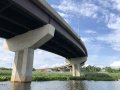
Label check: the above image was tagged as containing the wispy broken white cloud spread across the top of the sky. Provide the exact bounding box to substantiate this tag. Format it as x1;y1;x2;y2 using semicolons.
52;0;120;23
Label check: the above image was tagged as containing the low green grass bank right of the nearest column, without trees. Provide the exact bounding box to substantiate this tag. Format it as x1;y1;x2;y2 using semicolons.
33;72;120;81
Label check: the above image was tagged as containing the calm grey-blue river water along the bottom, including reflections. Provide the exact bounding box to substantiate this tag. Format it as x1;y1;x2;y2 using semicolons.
0;81;120;90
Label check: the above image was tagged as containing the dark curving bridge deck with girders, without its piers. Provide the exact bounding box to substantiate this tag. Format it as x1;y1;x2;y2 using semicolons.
0;0;87;58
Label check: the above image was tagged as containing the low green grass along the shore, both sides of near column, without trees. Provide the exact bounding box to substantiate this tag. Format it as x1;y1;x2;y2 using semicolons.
0;70;120;81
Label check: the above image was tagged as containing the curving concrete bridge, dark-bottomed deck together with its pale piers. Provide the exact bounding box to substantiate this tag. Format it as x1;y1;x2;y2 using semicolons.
0;0;87;82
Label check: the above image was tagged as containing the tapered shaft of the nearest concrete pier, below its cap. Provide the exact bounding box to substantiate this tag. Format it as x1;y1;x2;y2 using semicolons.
11;48;34;82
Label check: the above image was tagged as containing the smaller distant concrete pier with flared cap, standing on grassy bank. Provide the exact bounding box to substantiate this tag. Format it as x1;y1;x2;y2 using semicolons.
66;57;87;76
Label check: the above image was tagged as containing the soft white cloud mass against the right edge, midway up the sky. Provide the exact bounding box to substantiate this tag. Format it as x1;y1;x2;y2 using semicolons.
97;14;120;51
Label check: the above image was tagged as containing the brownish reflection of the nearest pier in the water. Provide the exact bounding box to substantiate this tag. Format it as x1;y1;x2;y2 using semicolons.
10;83;31;90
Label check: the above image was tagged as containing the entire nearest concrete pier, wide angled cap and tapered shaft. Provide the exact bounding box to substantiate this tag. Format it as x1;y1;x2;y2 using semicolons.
4;24;55;82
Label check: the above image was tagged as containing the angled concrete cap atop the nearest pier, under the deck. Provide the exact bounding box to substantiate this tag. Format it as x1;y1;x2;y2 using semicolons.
3;24;55;52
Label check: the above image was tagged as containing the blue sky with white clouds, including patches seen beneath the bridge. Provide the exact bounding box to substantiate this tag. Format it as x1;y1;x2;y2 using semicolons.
0;0;120;68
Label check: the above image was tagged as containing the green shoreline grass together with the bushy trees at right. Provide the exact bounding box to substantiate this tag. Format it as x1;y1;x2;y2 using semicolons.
0;66;120;81
